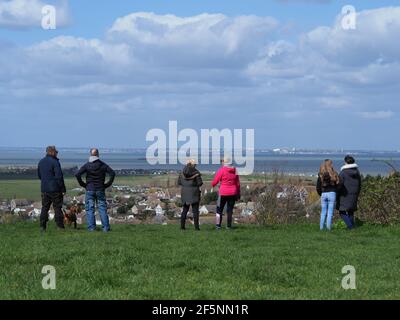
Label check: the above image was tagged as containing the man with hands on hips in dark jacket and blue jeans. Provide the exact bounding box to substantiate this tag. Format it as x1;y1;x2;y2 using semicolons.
75;149;115;232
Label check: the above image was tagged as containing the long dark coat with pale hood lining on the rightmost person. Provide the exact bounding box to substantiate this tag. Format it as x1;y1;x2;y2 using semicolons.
338;164;361;212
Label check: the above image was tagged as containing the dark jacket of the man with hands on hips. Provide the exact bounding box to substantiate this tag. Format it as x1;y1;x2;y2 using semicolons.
75;160;115;191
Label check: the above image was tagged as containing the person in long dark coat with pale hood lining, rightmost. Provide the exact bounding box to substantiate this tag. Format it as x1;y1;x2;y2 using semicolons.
338;156;361;230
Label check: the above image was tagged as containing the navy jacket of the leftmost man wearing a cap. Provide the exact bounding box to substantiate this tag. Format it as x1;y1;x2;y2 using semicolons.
38;156;66;193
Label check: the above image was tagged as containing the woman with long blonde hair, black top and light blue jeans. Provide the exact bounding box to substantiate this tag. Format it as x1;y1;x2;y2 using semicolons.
317;159;340;231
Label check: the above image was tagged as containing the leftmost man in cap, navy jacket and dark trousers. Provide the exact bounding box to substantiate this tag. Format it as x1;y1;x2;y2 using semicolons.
38;146;66;231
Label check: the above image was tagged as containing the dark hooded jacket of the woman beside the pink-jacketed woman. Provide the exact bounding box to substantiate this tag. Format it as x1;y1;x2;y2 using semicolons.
178;167;203;205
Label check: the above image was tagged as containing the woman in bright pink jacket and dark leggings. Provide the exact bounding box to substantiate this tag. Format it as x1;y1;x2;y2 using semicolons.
212;158;240;230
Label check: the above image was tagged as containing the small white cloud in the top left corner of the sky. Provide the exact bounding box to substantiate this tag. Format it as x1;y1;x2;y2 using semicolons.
0;0;69;28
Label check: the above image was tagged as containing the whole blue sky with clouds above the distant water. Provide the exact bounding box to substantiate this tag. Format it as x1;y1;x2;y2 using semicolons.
0;0;400;150
